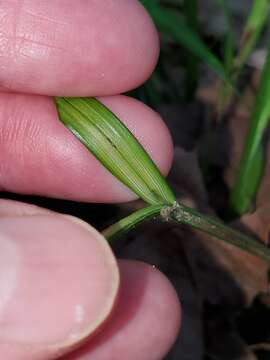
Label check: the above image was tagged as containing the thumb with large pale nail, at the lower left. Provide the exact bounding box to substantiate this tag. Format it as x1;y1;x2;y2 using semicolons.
0;213;119;360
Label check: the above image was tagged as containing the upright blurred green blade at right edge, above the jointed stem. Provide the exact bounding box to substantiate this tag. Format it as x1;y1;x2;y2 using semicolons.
230;48;270;214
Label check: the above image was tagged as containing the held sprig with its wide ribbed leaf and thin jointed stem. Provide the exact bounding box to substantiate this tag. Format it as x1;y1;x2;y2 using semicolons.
55;97;270;263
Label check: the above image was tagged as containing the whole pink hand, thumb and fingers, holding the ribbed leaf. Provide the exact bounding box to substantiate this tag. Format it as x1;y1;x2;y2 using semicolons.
0;0;180;360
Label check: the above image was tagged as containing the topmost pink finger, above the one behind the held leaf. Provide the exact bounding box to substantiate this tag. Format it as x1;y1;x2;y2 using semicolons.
0;0;159;96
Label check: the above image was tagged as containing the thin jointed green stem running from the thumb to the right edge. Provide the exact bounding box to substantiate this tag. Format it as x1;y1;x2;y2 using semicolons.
103;202;270;263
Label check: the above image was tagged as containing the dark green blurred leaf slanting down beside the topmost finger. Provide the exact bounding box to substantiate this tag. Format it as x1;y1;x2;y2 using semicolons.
141;0;230;82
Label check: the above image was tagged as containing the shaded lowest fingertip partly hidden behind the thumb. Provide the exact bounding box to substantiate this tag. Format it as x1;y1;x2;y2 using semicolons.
65;260;181;360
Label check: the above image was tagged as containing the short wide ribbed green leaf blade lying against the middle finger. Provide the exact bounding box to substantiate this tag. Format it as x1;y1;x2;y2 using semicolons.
55;97;175;205
